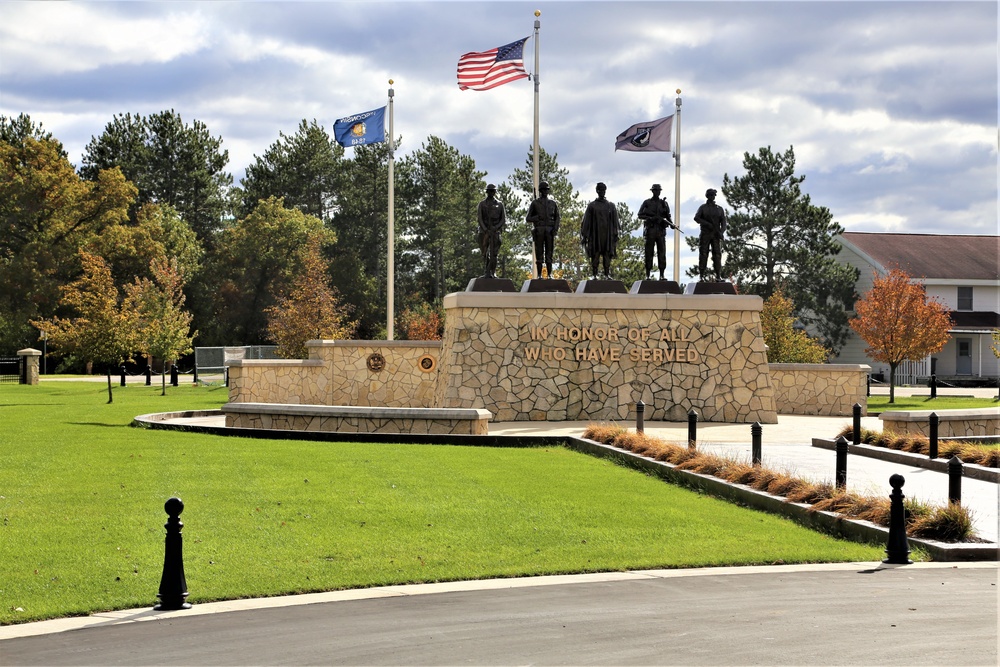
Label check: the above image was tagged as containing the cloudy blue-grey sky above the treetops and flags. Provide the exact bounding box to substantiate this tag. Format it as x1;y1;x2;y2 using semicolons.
0;0;998;247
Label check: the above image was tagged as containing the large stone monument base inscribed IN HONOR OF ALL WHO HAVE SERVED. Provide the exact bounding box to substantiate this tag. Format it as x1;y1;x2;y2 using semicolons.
434;292;777;424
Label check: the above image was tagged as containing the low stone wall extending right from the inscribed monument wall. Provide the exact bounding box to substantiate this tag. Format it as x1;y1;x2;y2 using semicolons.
768;364;871;417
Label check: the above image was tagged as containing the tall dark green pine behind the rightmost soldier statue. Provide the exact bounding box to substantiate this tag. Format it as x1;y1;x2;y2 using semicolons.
687;146;858;353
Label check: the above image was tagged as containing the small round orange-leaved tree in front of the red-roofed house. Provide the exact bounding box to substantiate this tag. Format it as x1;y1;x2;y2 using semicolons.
850;269;952;403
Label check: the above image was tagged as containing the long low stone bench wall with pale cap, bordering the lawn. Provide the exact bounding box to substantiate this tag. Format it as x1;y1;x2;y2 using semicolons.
222;403;493;435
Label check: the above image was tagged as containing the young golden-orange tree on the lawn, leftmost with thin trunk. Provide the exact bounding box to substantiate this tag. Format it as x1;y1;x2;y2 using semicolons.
31;251;140;403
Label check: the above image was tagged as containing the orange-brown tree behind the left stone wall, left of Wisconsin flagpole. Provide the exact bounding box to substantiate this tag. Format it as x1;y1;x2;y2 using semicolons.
267;237;357;359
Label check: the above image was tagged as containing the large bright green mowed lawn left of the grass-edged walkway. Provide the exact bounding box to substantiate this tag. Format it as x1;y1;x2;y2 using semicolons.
0;381;883;624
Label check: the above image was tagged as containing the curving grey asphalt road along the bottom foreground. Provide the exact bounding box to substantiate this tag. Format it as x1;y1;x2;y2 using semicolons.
0;563;998;666
